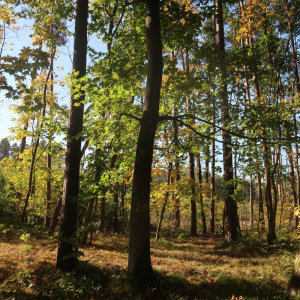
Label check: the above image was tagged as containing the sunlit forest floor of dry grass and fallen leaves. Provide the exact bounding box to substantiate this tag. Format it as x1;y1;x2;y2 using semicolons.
0;230;299;300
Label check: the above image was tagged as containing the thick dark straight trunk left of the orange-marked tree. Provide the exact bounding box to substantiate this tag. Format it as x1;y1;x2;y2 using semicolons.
56;0;88;270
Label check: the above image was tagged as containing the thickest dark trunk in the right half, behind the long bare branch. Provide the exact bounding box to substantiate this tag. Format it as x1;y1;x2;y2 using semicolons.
216;0;238;243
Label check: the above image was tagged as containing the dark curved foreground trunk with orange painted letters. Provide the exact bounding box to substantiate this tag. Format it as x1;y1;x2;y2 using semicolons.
128;0;163;281
